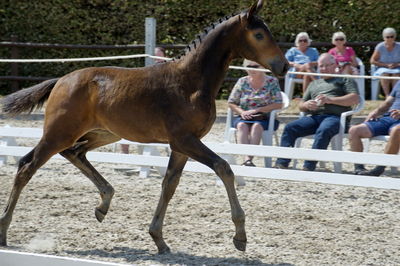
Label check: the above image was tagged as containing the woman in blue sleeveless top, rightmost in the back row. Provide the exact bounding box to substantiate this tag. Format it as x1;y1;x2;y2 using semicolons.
371;28;400;97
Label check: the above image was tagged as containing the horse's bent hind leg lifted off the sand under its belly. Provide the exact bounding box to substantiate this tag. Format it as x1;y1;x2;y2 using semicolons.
60;130;120;222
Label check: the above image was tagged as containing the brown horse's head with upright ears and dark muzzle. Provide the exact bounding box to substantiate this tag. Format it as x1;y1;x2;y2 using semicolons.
236;0;289;76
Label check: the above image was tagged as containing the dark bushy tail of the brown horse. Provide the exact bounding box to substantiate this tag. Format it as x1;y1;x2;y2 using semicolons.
1;78;58;115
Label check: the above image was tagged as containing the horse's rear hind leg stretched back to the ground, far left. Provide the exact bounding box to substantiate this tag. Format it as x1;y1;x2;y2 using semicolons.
0;139;69;246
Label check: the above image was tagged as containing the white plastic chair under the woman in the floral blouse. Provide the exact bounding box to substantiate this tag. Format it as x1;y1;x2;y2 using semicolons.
224;92;289;167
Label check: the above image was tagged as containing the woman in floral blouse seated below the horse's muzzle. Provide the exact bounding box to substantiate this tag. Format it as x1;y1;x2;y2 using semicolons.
228;59;282;166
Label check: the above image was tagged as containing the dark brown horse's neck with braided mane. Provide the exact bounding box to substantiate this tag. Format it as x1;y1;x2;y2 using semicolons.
183;19;236;99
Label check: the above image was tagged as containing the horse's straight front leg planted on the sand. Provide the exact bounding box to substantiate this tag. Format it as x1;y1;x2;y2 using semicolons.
149;151;188;254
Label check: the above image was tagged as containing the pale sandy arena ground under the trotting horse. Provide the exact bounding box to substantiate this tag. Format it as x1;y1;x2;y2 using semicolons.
0;116;400;265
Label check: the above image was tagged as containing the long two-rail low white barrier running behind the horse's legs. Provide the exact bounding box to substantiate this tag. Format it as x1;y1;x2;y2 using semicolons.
0;128;400;189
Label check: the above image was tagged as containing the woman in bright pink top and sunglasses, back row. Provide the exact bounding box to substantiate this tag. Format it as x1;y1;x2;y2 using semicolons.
328;31;359;75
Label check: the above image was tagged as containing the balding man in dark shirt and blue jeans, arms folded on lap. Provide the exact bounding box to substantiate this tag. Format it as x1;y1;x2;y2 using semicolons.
275;53;359;171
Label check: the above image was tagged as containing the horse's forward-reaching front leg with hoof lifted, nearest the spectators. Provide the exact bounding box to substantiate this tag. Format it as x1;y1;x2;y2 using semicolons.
170;135;247;251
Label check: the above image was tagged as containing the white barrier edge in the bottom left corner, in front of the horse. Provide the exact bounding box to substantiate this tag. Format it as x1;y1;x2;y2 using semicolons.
0;250;132;266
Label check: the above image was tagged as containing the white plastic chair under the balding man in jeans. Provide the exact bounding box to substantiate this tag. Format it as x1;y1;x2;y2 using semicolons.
293;95;365;173
